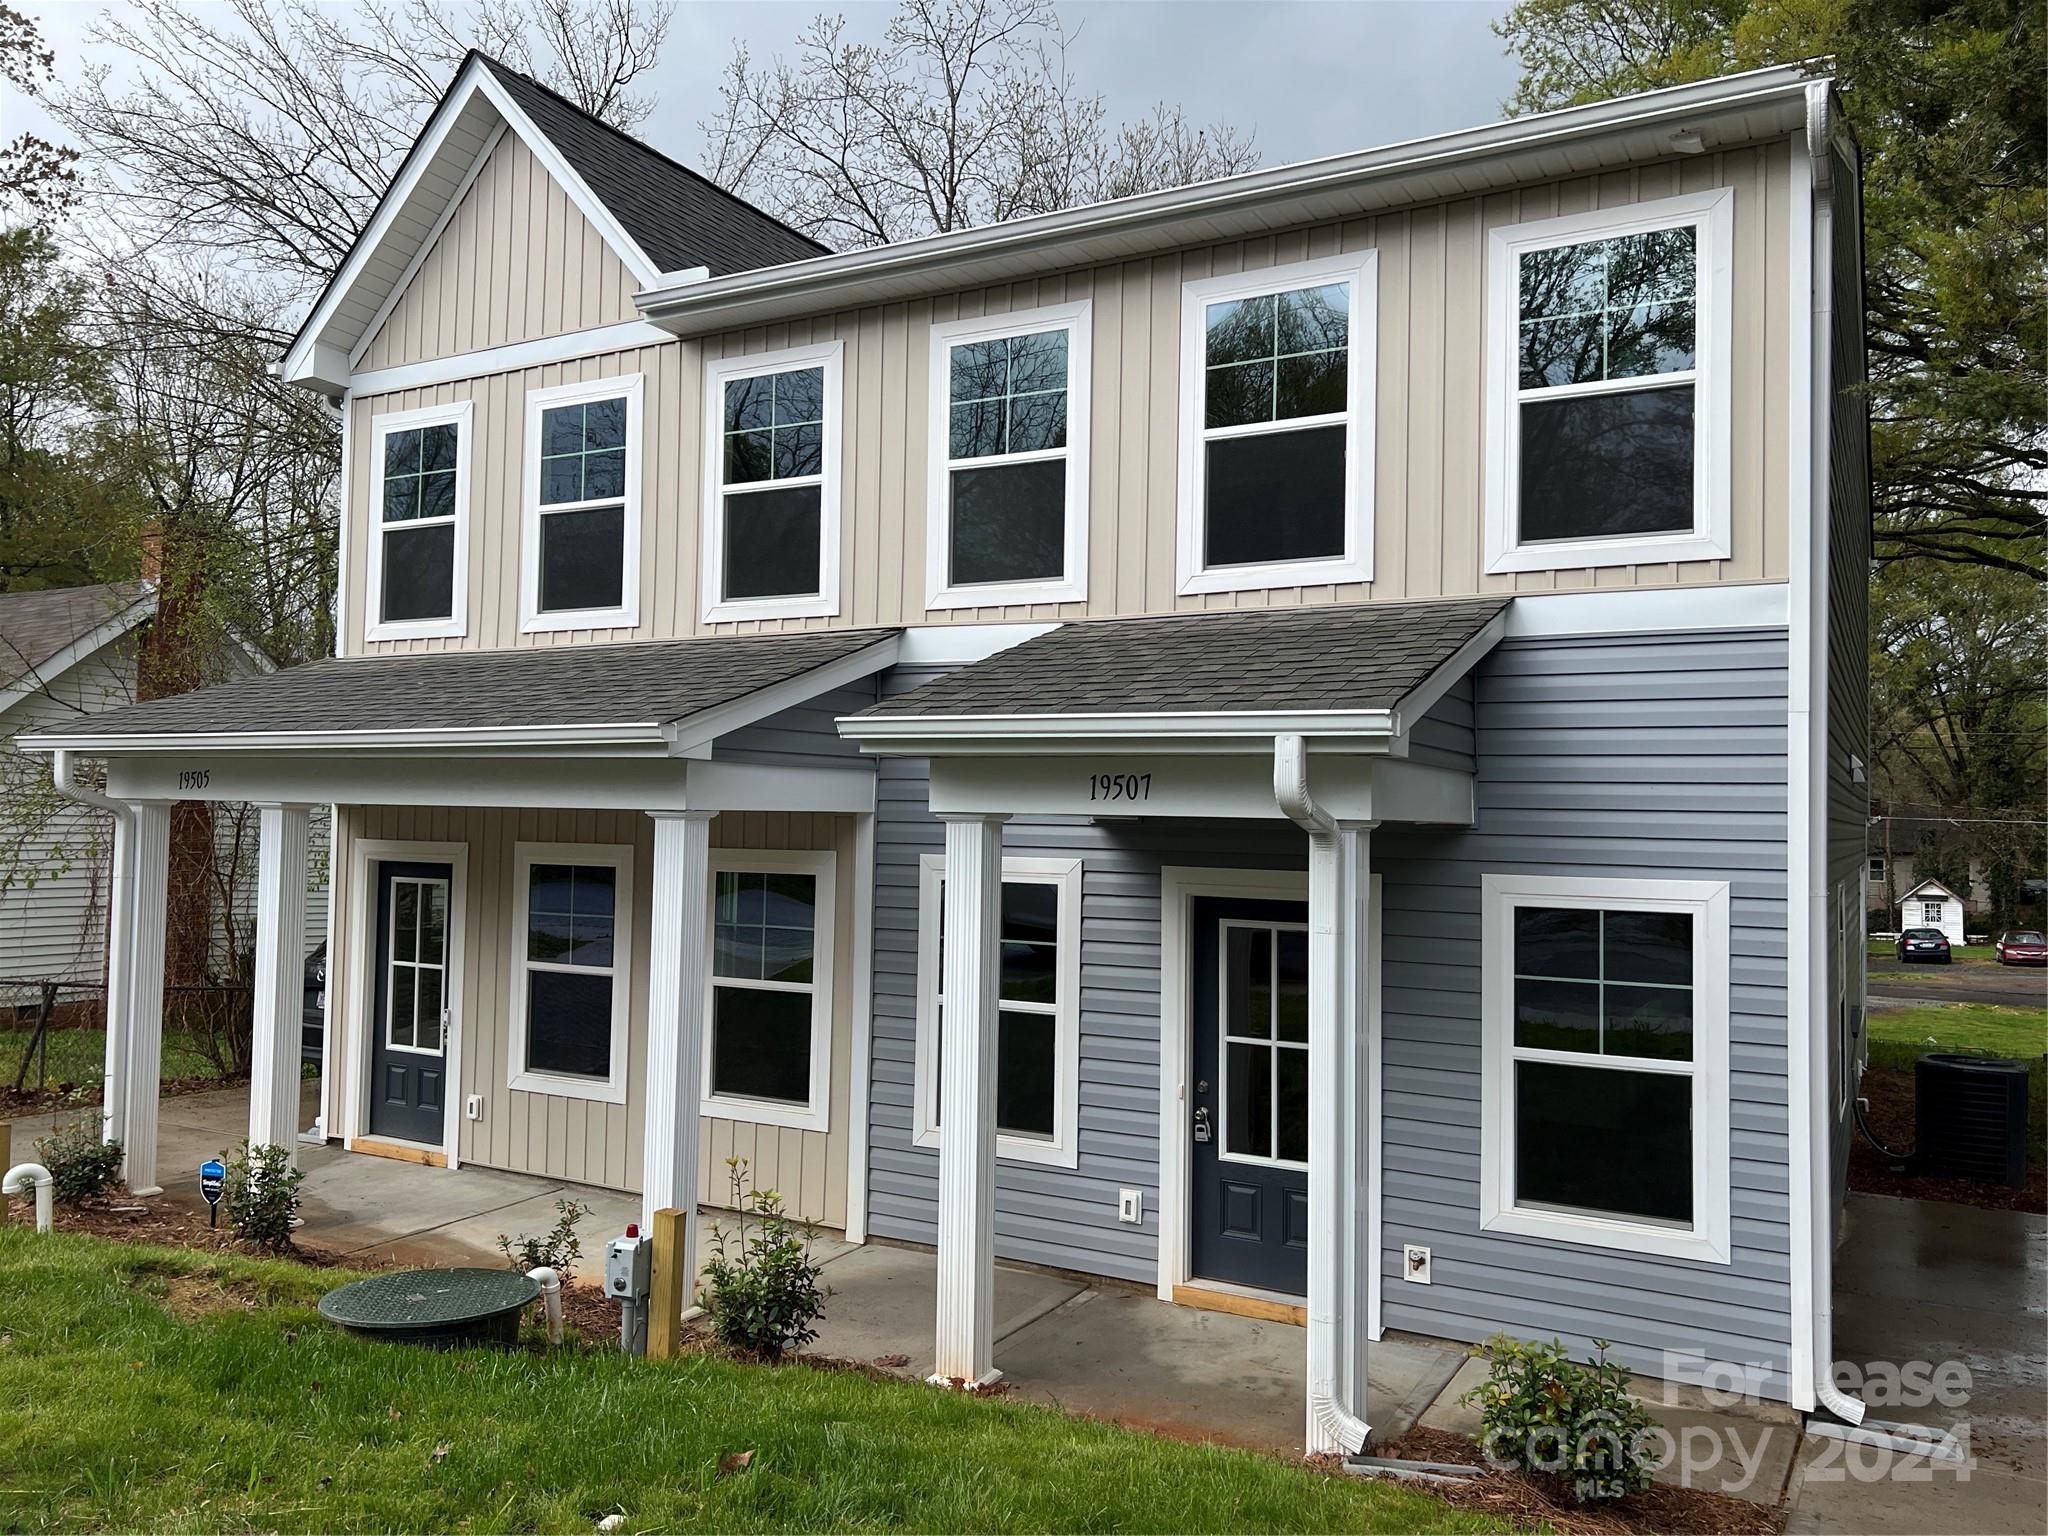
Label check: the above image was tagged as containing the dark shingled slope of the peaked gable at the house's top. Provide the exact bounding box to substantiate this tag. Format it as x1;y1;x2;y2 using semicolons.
477;53;829;276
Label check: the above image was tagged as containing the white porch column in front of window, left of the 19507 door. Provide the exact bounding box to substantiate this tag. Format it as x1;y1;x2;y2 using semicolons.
932;815;1008;1386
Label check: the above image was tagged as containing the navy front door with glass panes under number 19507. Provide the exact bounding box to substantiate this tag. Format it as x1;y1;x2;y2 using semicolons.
1190;899;1309;1296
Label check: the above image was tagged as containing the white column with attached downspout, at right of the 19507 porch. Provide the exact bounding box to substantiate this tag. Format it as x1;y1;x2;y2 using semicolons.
1274;735;1372;1454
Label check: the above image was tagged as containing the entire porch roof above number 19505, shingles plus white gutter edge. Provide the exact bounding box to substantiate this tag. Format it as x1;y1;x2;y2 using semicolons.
20;629;899;756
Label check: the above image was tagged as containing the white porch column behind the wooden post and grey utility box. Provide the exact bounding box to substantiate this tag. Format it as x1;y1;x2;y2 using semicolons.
641;811;717;1245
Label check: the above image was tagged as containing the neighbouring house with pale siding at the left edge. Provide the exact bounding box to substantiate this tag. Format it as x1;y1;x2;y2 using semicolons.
0;582;326;1008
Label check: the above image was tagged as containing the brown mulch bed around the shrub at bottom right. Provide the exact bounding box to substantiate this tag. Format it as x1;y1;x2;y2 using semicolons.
1372;1427;1784;1536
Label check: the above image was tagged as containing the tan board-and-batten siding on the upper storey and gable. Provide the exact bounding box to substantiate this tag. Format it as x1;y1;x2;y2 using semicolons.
344;139;1792;651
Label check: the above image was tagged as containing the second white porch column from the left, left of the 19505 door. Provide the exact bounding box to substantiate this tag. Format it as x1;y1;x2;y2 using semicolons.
250;801;307;1161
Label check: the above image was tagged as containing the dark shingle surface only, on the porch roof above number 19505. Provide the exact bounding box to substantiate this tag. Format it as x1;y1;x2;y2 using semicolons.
51;629;895;737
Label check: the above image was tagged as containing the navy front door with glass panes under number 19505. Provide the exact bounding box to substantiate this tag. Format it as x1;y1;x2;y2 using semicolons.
371;864;451;1147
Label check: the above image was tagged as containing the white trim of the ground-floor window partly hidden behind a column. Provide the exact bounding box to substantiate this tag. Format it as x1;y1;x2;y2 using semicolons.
911;854;1081;1167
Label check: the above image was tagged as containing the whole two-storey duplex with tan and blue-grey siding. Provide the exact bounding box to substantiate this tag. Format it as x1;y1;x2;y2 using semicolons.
19;57;1868;1450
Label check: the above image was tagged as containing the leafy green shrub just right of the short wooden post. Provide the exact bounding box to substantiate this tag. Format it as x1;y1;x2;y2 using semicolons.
698;1157;831;1360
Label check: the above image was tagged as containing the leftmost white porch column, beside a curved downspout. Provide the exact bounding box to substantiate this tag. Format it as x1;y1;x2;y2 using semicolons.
100;801;170;1196
